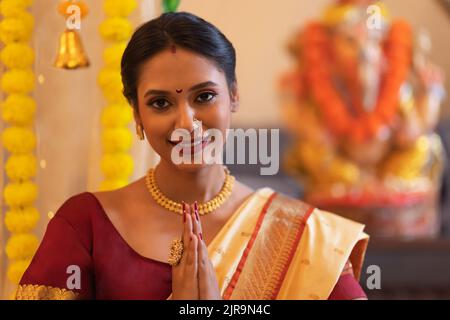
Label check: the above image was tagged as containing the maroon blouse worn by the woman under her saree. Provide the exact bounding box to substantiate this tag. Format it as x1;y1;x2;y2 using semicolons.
20;192;365;300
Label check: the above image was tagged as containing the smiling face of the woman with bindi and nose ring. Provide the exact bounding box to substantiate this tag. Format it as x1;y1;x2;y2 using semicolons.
134;47;238;169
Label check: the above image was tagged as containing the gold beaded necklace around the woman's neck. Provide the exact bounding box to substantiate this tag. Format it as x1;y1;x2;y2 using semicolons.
145;167;234;215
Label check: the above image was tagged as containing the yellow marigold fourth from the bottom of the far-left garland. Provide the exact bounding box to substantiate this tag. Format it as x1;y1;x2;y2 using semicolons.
3;181;38;209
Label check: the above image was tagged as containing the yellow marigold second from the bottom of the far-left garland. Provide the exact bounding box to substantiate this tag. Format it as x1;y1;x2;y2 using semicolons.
5;233;39;260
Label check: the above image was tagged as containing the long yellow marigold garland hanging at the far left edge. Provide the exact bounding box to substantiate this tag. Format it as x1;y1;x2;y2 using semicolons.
0;0;39;290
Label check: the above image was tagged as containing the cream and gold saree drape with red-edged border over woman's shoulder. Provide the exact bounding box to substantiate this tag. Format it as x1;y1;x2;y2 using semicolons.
208;188;368;300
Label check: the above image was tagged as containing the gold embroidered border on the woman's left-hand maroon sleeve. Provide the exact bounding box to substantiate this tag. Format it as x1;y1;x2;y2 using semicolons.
15;284;78;300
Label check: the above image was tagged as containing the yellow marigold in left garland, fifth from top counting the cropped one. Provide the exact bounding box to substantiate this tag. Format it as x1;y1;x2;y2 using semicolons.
0;94;36;126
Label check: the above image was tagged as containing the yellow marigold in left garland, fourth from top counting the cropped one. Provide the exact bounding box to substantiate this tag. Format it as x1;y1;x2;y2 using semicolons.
1;69;35;94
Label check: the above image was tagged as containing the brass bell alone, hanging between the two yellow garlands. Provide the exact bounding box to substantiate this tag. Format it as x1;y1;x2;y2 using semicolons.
54;29;89;69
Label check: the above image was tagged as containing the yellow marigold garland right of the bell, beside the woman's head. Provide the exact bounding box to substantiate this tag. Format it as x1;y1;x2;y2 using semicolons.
97;0;137;190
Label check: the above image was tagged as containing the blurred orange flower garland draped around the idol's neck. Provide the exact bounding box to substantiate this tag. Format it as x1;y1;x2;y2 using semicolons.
303;21;413;143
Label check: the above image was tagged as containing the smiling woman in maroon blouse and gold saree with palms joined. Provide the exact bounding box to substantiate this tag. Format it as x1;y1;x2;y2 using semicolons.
16;12;368;300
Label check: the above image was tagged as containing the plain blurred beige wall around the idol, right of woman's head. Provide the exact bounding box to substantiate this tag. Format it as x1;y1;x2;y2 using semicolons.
179;0;450;127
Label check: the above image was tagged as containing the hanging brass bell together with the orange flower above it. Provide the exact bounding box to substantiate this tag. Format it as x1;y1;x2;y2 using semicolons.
54;0;89;69
